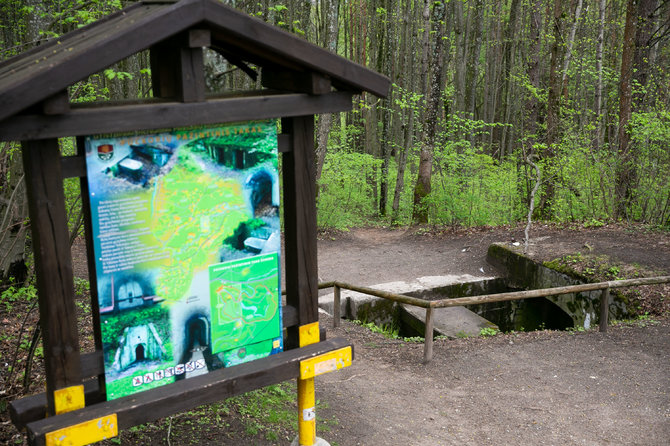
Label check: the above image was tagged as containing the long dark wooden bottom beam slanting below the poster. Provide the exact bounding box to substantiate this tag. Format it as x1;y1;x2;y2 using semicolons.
26;338;351;445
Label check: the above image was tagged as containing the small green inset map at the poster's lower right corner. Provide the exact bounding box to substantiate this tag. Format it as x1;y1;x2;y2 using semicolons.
209;253;281;353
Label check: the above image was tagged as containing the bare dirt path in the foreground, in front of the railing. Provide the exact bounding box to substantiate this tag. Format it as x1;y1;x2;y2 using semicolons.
316;317;670;446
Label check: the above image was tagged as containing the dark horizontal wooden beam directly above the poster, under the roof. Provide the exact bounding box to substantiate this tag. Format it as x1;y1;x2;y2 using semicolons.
0;92;352;141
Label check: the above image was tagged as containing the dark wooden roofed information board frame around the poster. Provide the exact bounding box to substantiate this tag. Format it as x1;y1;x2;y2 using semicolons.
0;0;390;444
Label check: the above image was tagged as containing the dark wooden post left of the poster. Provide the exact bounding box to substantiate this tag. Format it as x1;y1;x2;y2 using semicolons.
23;139;81;415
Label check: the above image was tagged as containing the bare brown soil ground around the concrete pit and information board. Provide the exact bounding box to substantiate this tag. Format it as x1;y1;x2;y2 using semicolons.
0;226;670;446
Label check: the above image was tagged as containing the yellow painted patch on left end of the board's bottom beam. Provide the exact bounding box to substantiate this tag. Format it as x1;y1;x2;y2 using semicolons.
44;413;119;446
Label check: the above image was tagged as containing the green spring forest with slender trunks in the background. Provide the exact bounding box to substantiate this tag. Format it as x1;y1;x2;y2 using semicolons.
0;0;670;275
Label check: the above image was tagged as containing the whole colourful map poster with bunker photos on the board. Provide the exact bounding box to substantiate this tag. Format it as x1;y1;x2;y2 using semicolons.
85;121;283;400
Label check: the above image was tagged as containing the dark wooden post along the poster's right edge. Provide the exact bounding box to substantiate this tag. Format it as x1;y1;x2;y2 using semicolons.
282;115;319;349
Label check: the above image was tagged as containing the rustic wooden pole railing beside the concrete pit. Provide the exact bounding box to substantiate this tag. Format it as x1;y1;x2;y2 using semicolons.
319;276;670;363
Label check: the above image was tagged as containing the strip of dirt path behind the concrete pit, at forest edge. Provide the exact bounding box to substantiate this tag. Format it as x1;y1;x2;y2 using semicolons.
319;225;670;285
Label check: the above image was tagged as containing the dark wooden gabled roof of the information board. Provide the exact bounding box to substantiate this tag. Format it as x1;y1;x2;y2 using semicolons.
0;0;390;121
